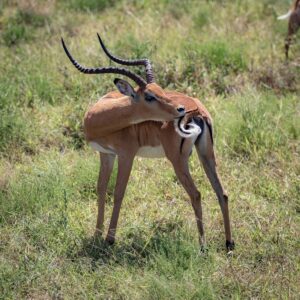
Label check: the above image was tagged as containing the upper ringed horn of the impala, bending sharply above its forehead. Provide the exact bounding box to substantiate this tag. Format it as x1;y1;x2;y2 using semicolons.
97;33;154;83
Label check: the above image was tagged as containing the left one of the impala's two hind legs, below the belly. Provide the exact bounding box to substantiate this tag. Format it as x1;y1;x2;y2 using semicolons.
172;155;206;250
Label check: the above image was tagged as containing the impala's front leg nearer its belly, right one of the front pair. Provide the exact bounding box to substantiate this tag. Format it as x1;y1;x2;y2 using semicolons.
106;155;134;244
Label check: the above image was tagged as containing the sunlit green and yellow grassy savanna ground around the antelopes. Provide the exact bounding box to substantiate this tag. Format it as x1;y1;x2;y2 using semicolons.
0;0;300;299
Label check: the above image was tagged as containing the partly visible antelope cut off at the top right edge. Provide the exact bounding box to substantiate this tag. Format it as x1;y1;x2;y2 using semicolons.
278;0;300;59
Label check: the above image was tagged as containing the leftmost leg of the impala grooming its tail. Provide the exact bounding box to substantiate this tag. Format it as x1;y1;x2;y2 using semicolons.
95;153;115;236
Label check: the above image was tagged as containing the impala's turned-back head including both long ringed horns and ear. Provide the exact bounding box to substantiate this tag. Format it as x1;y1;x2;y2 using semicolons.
62;34;186;121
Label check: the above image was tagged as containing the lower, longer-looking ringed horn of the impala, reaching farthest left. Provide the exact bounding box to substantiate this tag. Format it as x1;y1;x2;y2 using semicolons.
61;38;147;88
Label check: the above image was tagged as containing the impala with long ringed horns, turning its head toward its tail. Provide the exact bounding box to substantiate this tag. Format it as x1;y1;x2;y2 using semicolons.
62;34;234;251
